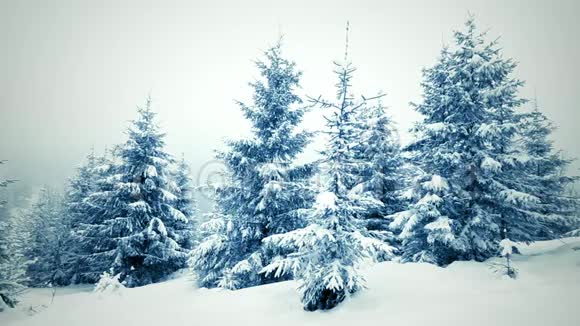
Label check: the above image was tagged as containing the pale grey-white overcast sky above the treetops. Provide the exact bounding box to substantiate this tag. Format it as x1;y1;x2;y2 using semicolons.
0;0;580;208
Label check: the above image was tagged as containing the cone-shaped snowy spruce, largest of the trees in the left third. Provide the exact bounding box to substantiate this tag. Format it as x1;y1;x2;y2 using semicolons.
81;98;193;287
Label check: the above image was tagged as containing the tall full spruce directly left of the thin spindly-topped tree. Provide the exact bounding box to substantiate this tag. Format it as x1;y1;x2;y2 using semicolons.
190;42;312;289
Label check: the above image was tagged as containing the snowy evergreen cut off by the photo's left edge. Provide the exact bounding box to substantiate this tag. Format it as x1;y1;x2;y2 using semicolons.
0;161;27;312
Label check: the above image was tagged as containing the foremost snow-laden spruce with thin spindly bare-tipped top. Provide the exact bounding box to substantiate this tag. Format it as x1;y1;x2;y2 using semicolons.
262;25;393;311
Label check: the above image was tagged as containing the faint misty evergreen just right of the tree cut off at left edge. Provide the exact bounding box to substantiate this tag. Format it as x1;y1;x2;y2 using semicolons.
26;188;74;287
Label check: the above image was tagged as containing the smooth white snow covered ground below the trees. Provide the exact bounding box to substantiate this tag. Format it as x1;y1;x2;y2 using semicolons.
0;238;580;326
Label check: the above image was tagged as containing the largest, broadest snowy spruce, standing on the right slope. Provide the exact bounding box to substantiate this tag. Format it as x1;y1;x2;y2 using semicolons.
393;17;538;265
